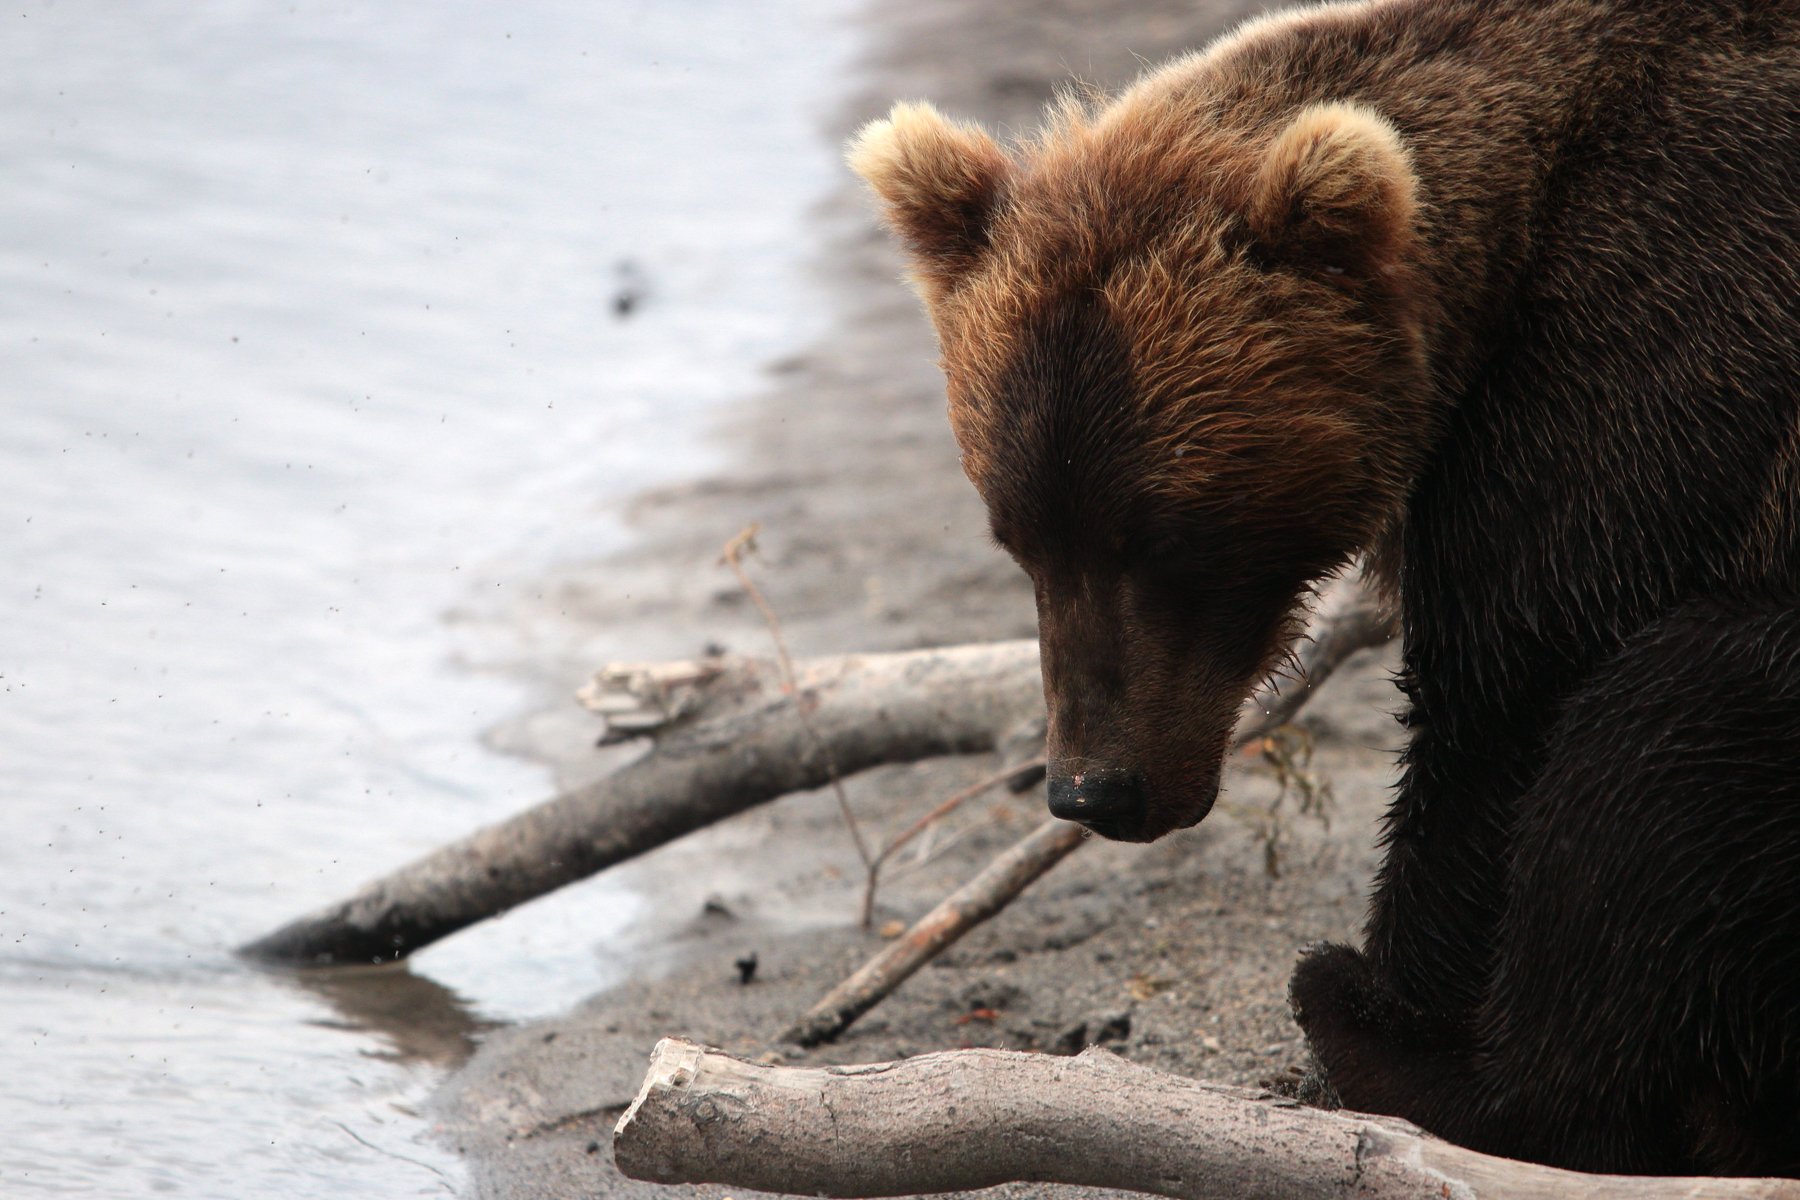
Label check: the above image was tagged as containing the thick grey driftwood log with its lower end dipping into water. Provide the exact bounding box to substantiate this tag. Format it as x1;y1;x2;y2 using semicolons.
239;640;1044;966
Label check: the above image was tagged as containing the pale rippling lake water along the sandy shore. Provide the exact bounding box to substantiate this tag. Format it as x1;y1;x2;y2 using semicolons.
0;0;851;1200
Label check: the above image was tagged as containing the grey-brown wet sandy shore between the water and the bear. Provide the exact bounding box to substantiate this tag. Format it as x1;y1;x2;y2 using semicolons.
437;0;1397;1200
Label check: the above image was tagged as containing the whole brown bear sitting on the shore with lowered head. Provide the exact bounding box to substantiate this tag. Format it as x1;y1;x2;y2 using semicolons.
851;0;1800;1173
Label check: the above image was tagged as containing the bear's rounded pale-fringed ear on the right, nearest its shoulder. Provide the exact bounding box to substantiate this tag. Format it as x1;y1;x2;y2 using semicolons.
1246;104;1418;282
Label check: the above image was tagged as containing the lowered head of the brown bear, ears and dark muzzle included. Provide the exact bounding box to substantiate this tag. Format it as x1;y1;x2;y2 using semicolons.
850;94;1431;840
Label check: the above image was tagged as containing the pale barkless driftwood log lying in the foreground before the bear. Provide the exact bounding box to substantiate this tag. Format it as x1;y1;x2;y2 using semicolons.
612;1038;1800;1200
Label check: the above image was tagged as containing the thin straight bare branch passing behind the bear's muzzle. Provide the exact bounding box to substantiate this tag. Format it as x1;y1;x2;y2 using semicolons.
781;578;1393;1045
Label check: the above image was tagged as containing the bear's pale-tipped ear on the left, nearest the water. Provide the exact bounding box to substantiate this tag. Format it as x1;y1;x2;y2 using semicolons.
850;104;1012;298
